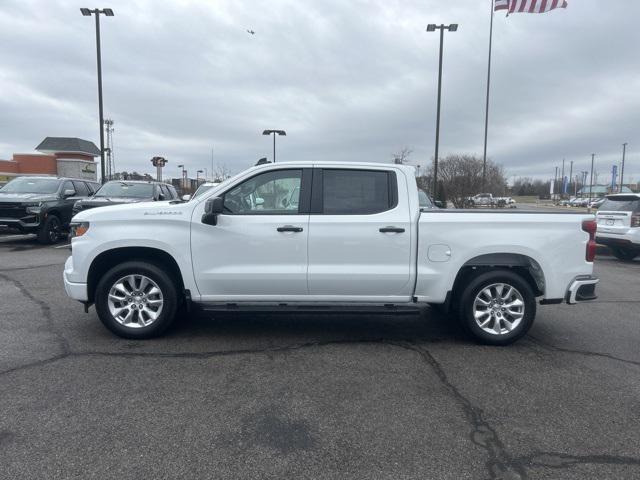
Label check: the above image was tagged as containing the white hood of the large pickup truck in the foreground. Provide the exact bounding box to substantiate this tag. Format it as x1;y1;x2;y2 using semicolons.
73;199;189;222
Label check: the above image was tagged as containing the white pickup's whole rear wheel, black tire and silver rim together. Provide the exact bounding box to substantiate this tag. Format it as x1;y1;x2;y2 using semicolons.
458;270;536;345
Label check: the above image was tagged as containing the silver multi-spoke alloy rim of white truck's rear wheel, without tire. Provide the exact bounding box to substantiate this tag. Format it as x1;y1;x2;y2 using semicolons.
473;283;524;335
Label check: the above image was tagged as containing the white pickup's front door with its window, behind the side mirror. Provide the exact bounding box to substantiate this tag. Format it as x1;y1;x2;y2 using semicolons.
191;169;311;301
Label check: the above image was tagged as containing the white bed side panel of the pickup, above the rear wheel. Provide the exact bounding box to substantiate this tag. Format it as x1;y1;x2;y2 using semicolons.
416;211;593;303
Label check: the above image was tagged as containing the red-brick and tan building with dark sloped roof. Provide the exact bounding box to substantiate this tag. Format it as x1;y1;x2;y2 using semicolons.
0;137;100;186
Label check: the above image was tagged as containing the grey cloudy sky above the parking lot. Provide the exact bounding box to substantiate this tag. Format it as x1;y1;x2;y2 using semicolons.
0;0;640;181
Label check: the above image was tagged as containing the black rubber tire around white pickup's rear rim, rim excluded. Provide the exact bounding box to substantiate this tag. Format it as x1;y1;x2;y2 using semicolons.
458;270;536;345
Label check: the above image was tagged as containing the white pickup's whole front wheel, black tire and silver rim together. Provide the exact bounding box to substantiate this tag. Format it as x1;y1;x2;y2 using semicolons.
95;261;178;339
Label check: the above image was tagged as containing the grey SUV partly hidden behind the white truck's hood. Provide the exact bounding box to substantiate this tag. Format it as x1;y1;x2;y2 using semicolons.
73;180;178;215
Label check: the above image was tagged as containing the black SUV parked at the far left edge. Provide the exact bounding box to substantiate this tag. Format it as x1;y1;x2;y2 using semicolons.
0;177;100;244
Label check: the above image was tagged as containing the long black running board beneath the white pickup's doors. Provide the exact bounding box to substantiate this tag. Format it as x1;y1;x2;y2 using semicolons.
198;302;424;314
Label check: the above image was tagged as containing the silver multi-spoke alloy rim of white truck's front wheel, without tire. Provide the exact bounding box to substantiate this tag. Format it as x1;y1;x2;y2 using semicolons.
107;274;164;328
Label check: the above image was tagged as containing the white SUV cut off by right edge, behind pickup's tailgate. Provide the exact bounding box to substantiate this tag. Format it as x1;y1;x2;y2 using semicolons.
596;193;640;261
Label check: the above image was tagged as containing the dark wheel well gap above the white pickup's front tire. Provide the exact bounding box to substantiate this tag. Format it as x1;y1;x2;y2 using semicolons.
87;247;184;303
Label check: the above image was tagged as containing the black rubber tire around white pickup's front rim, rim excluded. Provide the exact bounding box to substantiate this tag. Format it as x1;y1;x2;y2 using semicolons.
95;261;179;339
